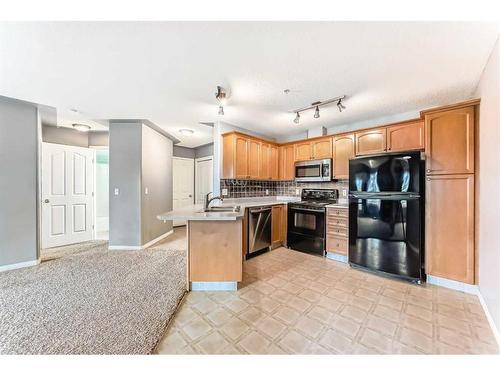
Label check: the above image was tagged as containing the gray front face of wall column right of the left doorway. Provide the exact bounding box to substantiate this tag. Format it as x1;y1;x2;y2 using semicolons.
109;123;142;246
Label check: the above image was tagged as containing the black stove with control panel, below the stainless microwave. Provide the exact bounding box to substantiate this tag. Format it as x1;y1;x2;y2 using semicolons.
287;189;339;256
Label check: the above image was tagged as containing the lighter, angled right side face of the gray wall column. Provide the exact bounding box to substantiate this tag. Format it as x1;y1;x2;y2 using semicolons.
141;125;173;244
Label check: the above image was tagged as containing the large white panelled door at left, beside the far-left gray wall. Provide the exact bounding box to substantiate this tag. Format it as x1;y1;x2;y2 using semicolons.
41;143;94;248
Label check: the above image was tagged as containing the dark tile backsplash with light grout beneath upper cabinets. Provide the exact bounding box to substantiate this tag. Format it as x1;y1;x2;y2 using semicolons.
220;179;349;198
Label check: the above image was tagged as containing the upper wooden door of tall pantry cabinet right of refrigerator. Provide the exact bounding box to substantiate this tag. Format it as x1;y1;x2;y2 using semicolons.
425;106;474;174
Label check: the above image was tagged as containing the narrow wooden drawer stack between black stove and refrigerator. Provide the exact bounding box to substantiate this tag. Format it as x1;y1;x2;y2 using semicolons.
326;208;349;256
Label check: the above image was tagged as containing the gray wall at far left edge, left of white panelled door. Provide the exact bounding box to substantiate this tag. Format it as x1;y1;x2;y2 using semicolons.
0;96;39;266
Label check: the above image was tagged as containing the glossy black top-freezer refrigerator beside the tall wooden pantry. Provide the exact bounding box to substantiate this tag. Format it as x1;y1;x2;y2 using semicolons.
349;152;425;283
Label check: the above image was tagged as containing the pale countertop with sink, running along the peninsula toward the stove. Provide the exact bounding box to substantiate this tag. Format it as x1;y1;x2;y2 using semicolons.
157;196;300;221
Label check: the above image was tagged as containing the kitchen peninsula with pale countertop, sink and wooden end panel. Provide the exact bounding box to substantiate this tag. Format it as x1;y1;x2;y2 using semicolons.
158;197;296;290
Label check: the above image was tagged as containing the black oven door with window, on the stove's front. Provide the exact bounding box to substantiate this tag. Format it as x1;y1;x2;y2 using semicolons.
287;206;325;255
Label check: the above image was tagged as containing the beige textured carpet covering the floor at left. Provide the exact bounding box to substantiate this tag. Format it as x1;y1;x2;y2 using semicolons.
0;242;186;354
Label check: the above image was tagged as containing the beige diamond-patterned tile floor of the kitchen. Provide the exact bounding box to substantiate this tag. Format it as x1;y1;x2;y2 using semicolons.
157;248;500;354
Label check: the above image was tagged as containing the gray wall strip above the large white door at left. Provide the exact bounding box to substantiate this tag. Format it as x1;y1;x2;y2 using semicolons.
42;125;109;147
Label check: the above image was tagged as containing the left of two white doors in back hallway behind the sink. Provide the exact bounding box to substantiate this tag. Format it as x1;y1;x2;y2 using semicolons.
172;157;194;226
